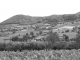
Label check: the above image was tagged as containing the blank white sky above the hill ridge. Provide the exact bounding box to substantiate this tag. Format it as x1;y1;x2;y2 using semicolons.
0;0;80;22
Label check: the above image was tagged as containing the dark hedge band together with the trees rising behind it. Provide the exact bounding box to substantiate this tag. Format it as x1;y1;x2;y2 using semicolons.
0;31;80;51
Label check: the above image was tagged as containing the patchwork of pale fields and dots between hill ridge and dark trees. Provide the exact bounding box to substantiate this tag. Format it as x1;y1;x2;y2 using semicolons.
0;21;80;41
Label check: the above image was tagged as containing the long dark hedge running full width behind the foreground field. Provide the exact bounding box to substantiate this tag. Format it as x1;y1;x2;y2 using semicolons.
0;38;80;51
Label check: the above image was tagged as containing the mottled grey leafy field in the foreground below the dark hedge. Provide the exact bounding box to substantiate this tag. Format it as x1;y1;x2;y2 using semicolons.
0;50;80;60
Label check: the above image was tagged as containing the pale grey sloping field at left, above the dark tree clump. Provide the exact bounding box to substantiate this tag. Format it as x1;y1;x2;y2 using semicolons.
0;30;39;42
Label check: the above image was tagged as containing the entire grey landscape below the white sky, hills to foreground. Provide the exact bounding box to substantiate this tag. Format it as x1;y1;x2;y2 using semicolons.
0;12;80;60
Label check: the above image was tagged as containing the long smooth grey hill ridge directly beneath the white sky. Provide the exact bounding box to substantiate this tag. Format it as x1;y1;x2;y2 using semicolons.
0;12;80;25
